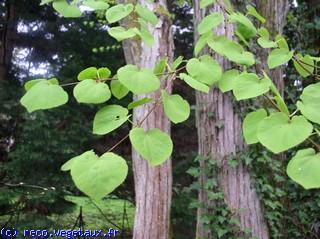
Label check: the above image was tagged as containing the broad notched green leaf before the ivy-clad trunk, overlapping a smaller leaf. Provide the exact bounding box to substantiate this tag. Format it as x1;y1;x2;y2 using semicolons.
233;72;271;100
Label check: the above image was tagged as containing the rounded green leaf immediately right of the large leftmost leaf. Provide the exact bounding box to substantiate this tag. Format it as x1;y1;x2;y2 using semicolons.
73;79;111;104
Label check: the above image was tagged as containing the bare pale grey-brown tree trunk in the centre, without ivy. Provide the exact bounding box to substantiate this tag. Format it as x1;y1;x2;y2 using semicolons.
120;0;174;239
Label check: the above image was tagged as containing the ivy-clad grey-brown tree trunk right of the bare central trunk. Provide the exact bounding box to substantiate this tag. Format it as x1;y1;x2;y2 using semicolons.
194;1;269;239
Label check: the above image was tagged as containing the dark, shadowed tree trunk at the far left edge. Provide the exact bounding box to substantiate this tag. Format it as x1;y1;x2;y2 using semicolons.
0;0;18;81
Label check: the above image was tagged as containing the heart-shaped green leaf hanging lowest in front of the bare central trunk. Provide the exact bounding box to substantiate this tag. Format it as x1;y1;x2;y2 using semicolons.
129;128;173;166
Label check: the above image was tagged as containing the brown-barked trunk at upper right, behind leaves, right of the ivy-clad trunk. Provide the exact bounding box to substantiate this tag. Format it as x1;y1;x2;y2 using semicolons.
256;0;289;95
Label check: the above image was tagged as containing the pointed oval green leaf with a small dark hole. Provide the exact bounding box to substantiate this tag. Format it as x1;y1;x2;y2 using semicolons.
93;105;130;135
